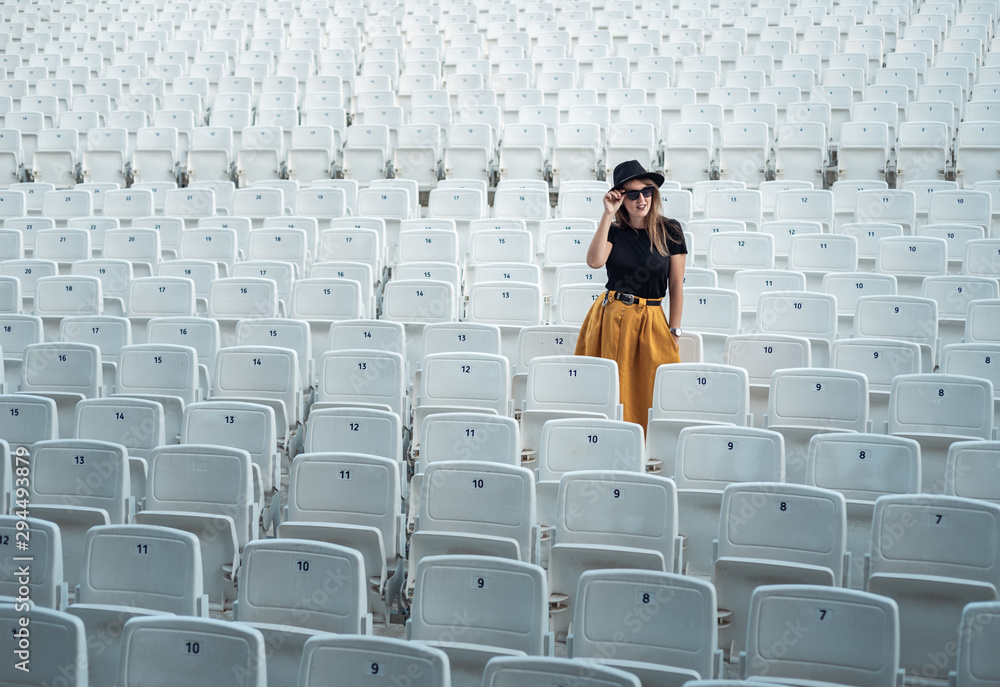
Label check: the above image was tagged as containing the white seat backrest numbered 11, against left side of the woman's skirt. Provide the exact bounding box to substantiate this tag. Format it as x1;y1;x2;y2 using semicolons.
525;355;619;419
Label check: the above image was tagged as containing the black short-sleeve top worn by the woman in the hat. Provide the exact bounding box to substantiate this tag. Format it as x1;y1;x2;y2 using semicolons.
605;219;687;299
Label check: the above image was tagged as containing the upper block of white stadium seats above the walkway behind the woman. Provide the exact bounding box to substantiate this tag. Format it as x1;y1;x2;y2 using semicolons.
0;2;1000;189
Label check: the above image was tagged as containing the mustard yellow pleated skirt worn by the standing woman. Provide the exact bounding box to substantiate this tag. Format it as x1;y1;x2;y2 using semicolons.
576;291;681;432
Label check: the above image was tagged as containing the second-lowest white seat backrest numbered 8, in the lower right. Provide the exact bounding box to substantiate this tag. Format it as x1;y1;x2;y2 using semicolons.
719;482;847;586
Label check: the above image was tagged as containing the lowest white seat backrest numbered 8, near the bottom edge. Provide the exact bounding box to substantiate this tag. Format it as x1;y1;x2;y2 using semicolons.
567;570;718;677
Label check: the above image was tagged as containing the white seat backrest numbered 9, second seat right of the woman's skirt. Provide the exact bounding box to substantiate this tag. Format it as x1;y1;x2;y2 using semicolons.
767;368;868;432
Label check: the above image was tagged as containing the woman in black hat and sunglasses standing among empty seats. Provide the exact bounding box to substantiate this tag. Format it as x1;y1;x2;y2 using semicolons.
576;160;687;431
